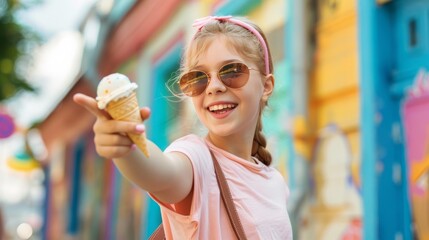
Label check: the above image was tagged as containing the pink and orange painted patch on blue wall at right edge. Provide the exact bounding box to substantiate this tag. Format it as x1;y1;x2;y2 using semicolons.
403;70;429;239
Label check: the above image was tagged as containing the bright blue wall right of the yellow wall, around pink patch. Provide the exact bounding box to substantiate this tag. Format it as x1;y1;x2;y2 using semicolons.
358;0;429;239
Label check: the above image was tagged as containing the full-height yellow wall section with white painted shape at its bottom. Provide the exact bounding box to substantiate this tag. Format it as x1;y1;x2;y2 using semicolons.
291;1;363;239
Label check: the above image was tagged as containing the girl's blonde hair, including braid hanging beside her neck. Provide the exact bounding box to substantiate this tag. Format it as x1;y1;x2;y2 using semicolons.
180;18;273;166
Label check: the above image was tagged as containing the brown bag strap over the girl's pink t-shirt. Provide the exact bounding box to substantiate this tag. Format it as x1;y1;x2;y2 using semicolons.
149;149;247;240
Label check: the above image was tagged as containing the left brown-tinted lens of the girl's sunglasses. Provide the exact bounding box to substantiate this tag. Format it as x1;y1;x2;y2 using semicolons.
179;71;208;97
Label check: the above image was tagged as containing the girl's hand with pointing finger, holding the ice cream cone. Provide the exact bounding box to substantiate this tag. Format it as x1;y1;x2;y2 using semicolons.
73;93;150;159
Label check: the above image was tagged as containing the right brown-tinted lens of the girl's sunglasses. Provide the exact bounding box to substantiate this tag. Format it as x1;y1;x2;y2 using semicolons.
219;63;249;88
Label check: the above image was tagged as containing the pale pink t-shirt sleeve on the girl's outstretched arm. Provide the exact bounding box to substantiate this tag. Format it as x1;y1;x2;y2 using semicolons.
150;135;213;220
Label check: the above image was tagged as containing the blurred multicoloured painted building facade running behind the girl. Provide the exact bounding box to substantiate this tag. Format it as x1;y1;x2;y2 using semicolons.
21;0;429;240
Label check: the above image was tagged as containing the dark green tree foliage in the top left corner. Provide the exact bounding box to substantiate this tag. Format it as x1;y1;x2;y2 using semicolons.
0;0;37;102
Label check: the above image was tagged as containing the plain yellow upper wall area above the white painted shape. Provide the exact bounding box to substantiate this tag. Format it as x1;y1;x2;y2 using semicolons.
310;0;360;153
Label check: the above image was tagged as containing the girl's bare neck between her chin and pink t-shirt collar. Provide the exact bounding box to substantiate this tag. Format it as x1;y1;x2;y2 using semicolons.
206;133;255;163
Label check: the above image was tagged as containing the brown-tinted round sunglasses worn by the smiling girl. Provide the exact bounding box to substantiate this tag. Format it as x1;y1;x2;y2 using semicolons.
179;62;258;97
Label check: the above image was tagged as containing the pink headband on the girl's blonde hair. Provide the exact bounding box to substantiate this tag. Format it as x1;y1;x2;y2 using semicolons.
192;16;270;75
